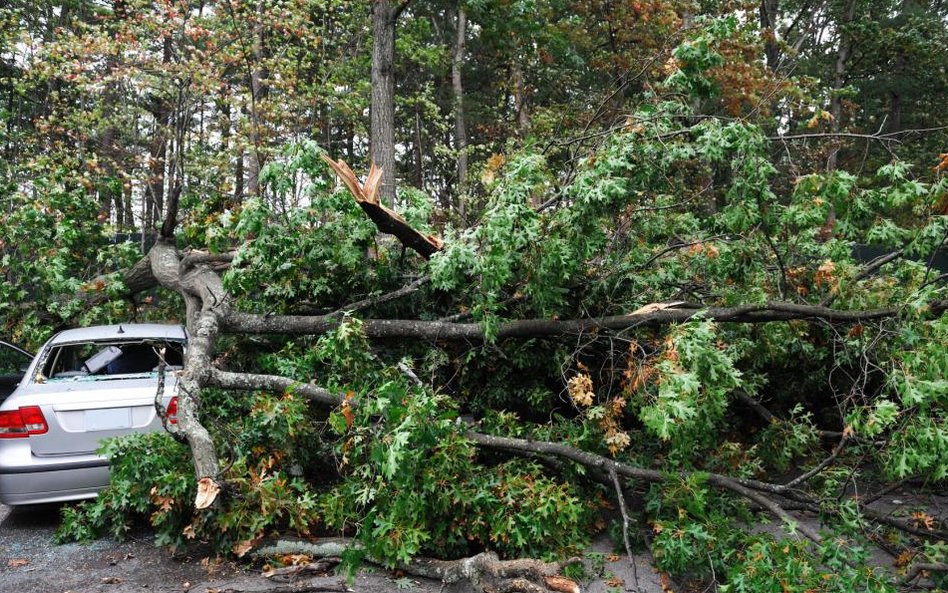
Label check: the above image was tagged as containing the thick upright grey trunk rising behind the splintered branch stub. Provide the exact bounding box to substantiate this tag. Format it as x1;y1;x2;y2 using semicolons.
370;0;398;208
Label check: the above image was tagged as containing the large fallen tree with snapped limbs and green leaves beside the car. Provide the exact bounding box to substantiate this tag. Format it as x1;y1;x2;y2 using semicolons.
33;117;946;593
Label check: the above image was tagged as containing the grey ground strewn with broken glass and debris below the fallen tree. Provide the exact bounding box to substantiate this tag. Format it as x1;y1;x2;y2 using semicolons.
0;505;662;593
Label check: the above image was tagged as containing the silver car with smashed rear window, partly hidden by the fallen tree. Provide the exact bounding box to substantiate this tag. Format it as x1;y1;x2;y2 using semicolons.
0;324;187;506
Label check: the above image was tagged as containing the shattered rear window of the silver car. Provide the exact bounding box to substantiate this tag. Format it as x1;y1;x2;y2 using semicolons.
35;340;184;383
